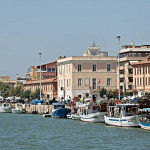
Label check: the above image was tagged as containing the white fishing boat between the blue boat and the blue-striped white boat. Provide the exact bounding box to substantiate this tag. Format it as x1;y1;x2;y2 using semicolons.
79;103;106;123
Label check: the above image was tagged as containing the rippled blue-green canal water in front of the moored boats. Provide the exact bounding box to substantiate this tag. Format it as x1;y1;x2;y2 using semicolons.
0;114;150;150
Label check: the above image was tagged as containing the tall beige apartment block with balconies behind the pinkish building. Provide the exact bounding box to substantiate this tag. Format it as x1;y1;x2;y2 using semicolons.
117;42;150;92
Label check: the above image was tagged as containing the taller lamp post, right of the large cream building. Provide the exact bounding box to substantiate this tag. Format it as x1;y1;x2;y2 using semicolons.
117;36;120;100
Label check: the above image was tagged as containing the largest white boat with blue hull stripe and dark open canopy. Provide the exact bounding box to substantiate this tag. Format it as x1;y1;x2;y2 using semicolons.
104;104;139;127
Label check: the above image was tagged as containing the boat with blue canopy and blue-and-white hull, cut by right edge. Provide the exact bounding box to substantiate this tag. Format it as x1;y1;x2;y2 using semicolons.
139;108;150;130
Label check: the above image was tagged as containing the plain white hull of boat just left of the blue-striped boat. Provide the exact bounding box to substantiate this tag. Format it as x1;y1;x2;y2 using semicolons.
80;112;105;123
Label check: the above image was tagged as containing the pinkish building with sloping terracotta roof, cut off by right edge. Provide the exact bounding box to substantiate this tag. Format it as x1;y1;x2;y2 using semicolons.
132;54;150;92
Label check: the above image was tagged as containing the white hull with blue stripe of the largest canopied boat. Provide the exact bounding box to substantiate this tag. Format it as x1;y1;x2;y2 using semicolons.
104;115;139;127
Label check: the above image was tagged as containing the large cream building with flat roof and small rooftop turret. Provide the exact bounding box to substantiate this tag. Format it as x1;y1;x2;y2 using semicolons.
57;45;117;99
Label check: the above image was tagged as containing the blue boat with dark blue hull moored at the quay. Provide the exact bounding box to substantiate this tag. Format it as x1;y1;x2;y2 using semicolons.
52;103;70;118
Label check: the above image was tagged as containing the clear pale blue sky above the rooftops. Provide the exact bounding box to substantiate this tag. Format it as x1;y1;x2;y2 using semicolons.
0;0;150;79
